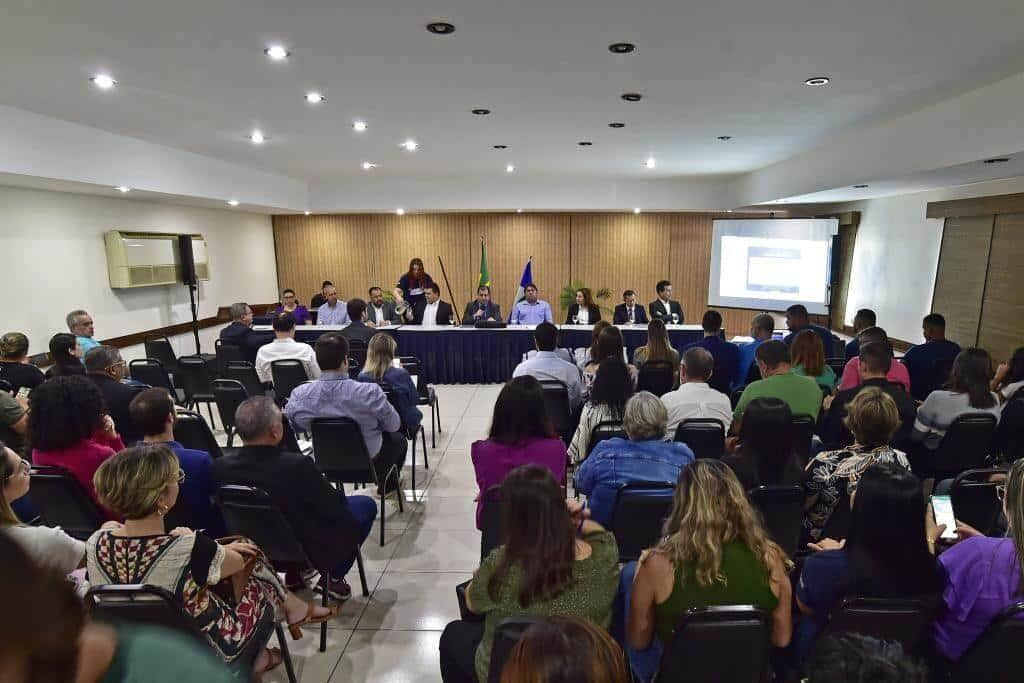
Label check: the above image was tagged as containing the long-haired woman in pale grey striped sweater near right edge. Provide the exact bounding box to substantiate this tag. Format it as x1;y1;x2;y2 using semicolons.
913;348;1000;451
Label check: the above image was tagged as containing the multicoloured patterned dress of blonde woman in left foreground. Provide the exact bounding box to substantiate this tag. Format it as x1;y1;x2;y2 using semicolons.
86;529;285;664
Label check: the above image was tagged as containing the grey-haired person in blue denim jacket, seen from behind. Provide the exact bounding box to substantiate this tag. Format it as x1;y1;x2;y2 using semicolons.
575;391;693;525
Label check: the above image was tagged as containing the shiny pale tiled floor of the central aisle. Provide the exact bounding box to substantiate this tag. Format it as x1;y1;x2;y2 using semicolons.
256;385;501;683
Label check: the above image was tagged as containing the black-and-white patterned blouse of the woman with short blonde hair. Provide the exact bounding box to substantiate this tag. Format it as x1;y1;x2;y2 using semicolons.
804;443;910;541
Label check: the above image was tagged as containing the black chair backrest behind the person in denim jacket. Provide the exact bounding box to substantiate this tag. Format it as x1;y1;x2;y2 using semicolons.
611;481;676;562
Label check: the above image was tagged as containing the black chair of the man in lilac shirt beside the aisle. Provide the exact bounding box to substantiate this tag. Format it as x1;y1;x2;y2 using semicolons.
310;418;406;546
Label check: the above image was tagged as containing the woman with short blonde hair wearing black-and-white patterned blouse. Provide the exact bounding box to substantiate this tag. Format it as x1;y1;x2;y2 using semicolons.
804;387;910;541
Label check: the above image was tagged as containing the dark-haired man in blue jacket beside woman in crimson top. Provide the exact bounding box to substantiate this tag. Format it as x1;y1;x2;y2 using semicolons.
128;388;221;530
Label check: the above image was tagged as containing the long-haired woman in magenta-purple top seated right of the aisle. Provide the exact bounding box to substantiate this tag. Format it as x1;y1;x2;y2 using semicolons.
470;375;565;528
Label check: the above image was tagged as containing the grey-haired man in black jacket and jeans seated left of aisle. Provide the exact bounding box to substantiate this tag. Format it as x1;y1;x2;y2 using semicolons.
212;396;377;600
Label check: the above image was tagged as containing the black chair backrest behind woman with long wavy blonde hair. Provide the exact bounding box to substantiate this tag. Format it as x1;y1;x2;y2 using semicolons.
656;605;771;683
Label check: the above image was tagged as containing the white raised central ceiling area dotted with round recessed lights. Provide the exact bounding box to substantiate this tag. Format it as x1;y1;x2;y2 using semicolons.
6;0;1024;191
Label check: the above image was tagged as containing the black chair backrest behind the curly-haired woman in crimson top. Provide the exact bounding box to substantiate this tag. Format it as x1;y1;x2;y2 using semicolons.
30;466;103;540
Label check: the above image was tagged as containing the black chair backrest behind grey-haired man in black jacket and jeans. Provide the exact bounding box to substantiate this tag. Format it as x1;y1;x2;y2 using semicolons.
216;485;309;565
